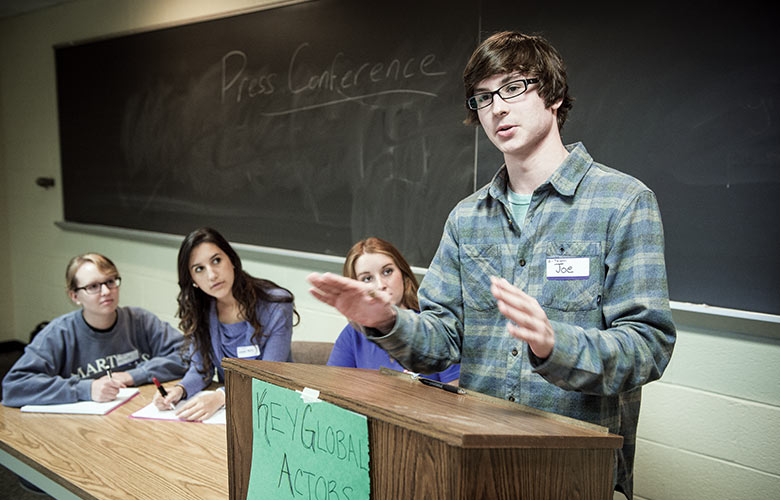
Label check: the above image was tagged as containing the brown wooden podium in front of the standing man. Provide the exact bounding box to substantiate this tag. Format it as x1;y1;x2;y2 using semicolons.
222;359;623;500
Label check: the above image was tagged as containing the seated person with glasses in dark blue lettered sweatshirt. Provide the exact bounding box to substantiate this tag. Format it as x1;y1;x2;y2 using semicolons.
3;253;186;406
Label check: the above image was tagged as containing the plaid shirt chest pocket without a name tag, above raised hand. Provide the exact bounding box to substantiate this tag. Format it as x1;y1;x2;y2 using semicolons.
460;244;502;311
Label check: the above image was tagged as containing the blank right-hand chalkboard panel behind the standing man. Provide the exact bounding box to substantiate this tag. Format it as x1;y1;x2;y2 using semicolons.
478;0;780;314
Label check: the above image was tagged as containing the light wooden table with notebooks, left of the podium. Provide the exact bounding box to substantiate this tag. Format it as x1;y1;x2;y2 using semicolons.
0;384;228;500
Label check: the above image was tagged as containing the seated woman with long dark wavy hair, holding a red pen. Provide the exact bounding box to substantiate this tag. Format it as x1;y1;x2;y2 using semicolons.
154;228;298;420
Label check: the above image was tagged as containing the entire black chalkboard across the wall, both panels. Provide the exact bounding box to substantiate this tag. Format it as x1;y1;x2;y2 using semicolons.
56;0;780;314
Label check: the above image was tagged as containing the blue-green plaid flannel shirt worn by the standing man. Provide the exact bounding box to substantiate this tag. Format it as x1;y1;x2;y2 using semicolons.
367;143;676;498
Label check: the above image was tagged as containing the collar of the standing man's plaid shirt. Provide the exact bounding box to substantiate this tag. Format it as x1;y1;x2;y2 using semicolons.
479;142;593;201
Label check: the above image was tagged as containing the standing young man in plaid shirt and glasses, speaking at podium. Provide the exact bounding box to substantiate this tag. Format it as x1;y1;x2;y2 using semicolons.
309;32;676;498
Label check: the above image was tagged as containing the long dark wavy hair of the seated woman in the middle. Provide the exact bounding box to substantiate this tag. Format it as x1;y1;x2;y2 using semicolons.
176;227;300;379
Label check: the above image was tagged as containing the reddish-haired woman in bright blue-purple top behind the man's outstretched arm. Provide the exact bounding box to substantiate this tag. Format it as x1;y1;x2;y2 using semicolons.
328;238;460;383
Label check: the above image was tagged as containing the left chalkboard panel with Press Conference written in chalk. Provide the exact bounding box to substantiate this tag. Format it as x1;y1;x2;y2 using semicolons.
55;0;479;266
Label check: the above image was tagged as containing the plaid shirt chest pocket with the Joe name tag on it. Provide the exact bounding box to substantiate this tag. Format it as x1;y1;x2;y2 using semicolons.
539;241;604;311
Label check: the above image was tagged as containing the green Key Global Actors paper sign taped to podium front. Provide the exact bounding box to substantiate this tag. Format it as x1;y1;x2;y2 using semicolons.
247;379;371;500
